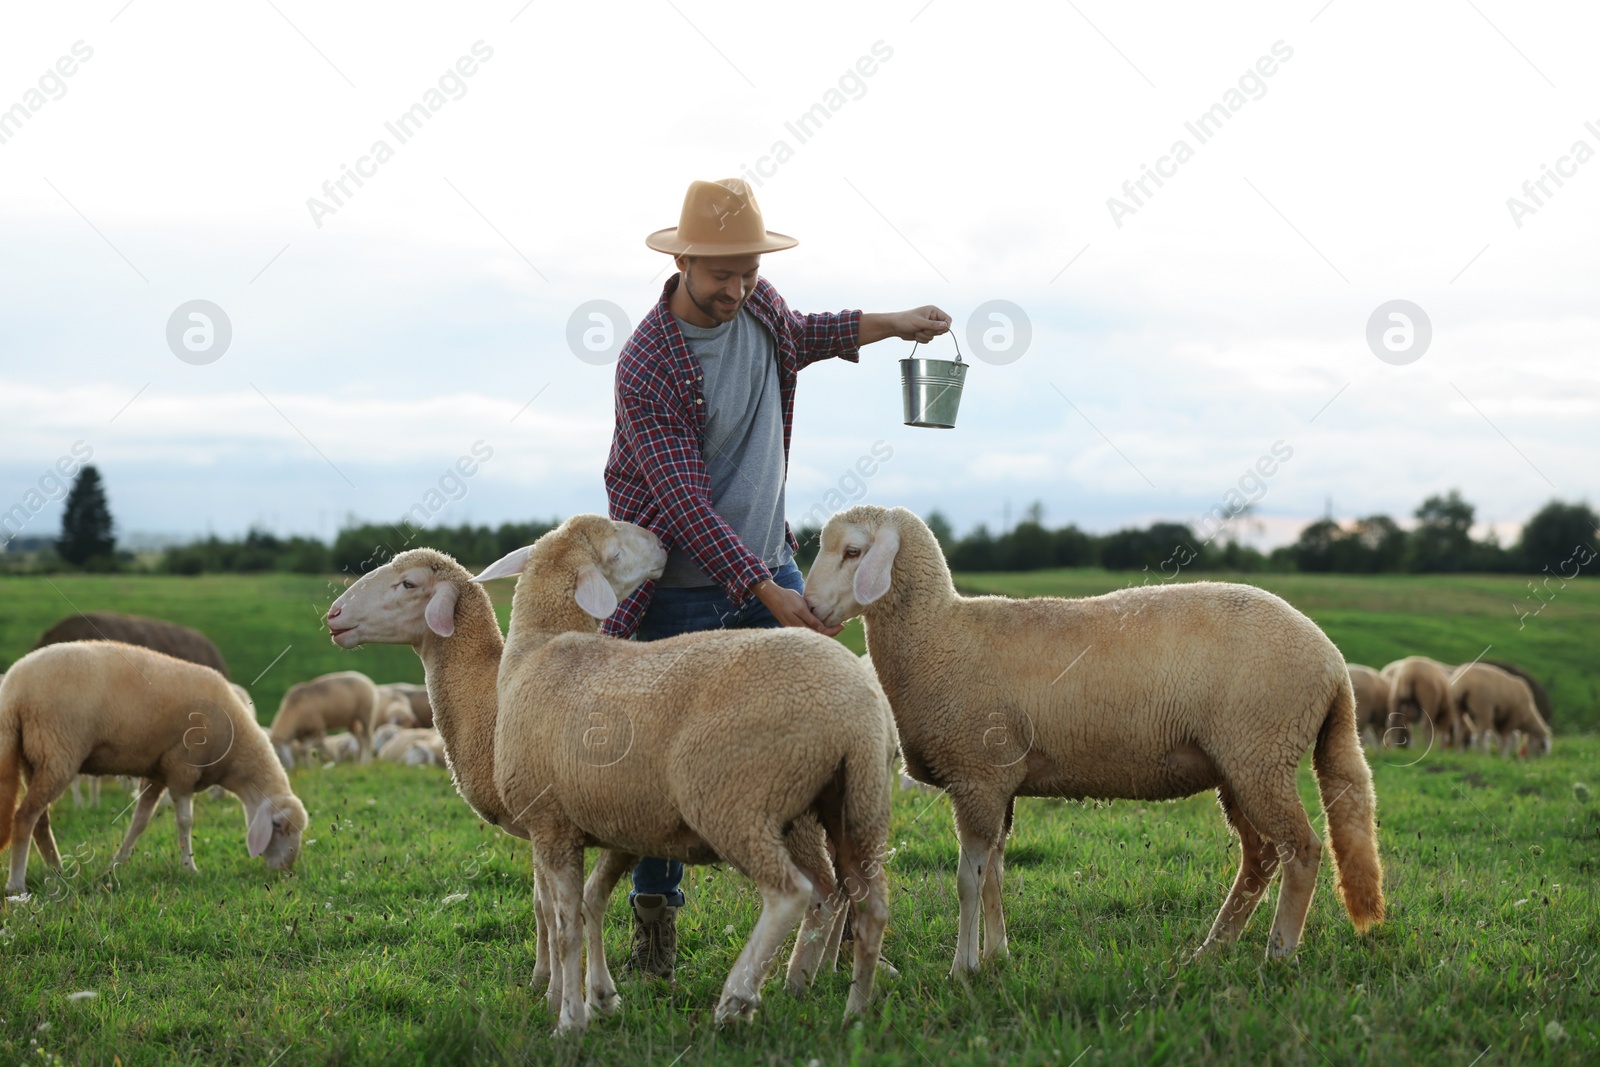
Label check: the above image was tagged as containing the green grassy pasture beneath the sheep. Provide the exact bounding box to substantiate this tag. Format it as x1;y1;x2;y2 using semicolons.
0;571;1600;1067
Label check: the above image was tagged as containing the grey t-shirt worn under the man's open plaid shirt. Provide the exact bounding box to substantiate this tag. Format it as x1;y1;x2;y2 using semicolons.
658;309;794;589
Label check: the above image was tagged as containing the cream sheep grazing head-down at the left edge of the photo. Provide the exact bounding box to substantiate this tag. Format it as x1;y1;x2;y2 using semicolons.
0;641;307;893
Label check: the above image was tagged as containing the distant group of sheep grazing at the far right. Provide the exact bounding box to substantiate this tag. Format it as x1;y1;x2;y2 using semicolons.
1350;656;1550;755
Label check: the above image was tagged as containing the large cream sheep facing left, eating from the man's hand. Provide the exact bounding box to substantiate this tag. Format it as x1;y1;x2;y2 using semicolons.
805;504;1384;976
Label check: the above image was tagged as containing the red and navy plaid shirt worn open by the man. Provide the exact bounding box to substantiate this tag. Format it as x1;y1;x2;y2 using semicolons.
602;274;861;637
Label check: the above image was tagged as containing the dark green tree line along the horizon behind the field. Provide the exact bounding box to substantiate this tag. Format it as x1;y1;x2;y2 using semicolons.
8;466;1600;577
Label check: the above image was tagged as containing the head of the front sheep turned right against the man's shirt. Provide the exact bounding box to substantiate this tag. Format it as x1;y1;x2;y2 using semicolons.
472;515;667;629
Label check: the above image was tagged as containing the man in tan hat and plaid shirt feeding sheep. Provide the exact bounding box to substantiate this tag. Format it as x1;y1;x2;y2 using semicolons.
603;178;950;979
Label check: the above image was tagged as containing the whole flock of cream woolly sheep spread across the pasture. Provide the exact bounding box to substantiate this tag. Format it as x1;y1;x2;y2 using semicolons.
0;506;1549;1032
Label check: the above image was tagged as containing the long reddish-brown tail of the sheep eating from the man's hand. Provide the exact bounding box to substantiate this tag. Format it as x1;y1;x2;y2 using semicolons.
1312;670;1384;933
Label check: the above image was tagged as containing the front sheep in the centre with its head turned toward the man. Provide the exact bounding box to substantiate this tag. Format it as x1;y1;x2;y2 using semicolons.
477;515;894;1033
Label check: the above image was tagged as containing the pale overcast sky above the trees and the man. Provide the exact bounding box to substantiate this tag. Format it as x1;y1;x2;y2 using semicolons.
0;0;1600;544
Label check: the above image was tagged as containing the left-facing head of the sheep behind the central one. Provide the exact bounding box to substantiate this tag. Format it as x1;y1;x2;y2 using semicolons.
328;549;473;648
